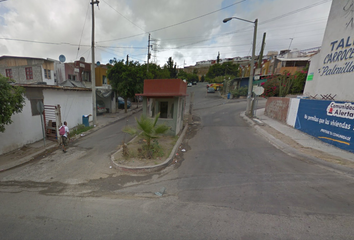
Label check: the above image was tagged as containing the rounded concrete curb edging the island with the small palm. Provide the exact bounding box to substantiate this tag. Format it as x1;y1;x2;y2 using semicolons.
111;124;188;173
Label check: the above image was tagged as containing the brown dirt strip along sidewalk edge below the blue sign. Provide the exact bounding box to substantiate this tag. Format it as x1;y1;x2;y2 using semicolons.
261;125;354;169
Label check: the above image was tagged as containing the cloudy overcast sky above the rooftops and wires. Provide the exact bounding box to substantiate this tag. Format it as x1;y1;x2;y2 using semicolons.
0;0;332;67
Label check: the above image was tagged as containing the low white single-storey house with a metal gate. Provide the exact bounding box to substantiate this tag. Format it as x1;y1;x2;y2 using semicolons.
0;84;92;154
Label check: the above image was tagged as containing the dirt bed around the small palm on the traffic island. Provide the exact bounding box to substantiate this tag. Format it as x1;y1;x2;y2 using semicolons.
113;136;178;167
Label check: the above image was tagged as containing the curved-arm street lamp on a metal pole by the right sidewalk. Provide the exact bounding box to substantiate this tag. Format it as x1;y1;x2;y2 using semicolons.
223;17;258;118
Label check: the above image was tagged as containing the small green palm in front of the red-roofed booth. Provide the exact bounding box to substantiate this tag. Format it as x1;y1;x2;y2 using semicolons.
123;113;170;149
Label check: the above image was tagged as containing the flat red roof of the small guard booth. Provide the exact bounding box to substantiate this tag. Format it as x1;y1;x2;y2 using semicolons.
136;79;187;97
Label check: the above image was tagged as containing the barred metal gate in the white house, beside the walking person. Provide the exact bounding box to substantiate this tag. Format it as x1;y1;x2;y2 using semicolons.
43;105;61;143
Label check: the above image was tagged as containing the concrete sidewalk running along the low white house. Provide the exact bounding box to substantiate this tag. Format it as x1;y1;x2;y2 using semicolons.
0;103;142;172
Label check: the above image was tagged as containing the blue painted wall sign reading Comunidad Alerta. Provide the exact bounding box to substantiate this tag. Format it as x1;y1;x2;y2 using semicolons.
295;99;354;152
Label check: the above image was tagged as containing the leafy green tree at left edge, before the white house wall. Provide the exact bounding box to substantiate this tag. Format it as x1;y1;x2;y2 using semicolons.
0;75;25;132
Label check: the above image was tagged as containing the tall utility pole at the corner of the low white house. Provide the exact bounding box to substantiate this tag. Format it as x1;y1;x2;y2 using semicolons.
91;0;100;125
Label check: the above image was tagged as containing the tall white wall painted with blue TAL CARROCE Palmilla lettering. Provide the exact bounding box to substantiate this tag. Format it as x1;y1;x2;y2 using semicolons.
304;0;354;101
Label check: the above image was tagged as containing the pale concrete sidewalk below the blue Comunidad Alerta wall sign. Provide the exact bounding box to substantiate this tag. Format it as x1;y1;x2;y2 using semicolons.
241;108;354;174
